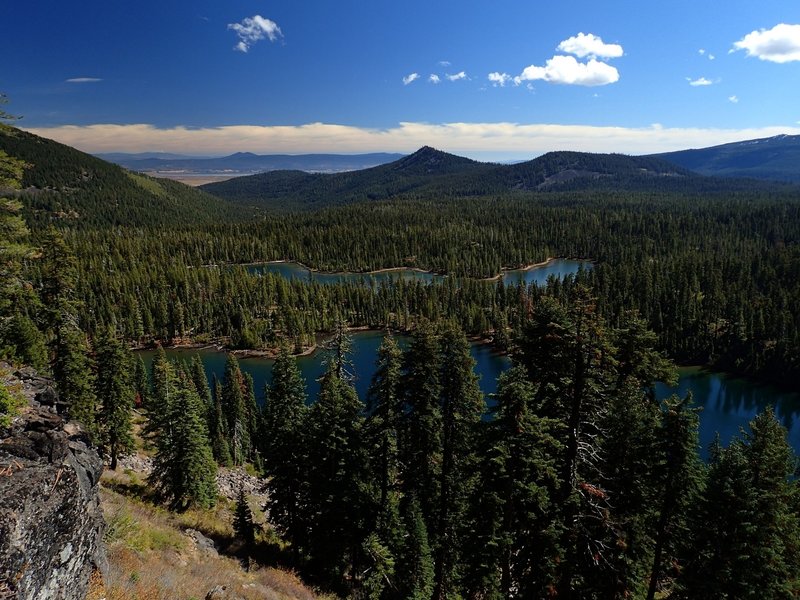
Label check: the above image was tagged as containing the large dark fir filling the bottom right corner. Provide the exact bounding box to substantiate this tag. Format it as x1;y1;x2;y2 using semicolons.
678;408;800;600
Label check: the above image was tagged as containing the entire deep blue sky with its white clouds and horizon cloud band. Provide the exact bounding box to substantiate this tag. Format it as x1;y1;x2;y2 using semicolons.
0;0;800;160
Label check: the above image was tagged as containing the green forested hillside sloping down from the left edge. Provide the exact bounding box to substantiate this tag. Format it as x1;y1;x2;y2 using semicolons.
0;125;238;226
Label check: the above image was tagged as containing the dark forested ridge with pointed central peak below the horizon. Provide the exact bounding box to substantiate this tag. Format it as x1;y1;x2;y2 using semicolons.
201;146;768;210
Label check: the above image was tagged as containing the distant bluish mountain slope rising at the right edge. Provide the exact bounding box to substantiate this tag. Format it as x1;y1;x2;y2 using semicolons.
651;135;800;182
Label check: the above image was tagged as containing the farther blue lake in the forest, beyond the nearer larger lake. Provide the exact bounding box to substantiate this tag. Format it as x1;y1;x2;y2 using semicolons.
246;258;592;285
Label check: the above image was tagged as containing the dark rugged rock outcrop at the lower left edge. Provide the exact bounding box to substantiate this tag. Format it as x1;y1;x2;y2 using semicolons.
0;370;105;600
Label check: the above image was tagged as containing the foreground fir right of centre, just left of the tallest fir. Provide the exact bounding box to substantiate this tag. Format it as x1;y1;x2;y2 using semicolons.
466;366;561;598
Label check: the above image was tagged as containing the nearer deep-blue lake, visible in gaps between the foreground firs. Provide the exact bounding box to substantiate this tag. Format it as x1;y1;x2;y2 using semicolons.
139;331;800;458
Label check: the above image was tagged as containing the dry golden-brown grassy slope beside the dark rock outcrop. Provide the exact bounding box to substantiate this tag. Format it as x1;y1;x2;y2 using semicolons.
95;473;330;600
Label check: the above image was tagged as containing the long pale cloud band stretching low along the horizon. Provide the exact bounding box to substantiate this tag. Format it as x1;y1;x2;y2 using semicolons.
27;122;800;160
